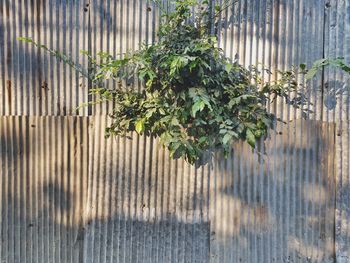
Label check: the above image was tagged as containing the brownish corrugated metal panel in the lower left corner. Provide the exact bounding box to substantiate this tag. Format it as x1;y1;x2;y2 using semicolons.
0;116;88;263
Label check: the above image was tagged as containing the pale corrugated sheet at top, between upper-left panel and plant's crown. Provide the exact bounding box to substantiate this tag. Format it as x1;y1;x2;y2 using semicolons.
91;0;159;115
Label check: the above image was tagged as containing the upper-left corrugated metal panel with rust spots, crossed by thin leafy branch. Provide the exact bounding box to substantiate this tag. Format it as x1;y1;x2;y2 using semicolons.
0;0;90;116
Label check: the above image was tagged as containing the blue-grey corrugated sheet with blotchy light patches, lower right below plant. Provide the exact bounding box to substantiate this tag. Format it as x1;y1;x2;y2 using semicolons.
212;121;335;262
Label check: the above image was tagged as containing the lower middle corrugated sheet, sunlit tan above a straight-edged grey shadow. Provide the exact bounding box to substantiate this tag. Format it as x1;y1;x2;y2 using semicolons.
84;117;210;262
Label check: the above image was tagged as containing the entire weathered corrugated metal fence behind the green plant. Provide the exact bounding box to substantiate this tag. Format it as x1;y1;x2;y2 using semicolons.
0;0;350;263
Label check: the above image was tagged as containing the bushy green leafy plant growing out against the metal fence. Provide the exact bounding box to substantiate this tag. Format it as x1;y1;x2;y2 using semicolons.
17;0;308;164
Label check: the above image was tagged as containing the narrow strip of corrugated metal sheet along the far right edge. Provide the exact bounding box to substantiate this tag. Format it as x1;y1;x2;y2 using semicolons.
323;0;350;263
